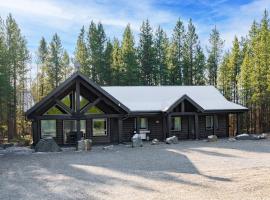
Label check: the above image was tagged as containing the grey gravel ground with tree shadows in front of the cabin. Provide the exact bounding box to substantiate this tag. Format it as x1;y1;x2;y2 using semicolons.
0;140;270;200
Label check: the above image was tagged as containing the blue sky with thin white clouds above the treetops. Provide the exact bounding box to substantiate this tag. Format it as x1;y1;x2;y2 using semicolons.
0;0;270;74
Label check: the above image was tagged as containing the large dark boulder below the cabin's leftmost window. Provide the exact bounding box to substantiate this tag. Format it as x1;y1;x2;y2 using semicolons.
35;137;62;152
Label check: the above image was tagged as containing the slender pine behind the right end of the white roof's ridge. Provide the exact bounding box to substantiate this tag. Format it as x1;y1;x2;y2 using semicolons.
207;26;224;86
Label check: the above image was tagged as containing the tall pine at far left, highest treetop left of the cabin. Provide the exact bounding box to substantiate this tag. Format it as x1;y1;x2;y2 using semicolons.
5;14;29;139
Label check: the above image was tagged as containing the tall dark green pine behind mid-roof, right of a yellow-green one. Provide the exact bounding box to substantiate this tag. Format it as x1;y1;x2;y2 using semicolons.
138;20;155;85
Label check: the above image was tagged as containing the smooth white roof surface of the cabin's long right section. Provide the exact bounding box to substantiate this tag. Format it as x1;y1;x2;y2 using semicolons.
102;86;247;111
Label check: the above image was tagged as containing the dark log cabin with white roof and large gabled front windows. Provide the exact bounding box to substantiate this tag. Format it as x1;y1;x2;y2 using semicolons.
26;72;247;145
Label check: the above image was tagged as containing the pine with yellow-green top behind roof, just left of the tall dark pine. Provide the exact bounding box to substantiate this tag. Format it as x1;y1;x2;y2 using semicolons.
121;24;139;85
